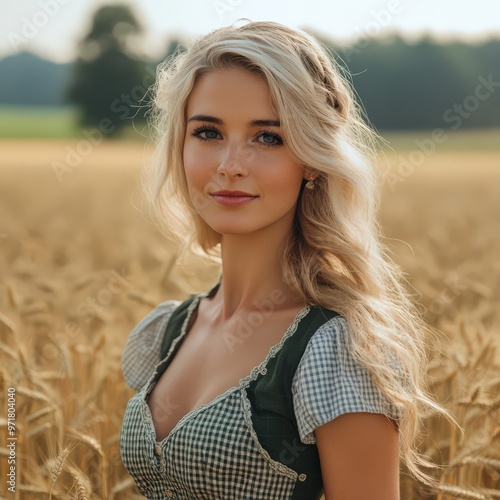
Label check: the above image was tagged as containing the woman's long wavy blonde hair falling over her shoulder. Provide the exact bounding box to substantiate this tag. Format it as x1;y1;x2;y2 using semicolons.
143;22;457;485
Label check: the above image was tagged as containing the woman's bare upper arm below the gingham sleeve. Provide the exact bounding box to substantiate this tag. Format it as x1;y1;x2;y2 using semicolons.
314;412;399;500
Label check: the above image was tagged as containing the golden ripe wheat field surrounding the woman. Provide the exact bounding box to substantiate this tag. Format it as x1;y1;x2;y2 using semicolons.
0;140;500;500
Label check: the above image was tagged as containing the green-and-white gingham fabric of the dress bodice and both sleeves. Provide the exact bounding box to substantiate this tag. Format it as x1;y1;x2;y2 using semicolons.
120;294;398;500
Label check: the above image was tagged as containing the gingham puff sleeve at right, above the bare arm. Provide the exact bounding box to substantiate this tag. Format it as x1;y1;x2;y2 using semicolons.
292;316;397;444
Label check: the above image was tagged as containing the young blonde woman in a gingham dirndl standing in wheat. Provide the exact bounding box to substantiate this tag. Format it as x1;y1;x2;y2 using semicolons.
120;22;458;500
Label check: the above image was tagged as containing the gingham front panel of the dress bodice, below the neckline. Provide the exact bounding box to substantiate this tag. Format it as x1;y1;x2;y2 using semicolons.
120;388;307;500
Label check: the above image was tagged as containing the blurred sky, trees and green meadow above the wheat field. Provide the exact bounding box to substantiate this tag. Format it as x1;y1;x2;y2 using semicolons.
0;0;500;137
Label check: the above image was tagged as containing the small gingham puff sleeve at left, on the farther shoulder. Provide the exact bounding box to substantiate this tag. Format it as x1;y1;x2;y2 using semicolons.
122;300;180;391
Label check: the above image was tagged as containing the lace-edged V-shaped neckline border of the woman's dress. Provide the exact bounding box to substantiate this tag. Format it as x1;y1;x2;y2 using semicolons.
140;278;311;446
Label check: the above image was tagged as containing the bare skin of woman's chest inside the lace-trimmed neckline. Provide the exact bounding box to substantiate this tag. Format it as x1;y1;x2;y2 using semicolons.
147;308;298;440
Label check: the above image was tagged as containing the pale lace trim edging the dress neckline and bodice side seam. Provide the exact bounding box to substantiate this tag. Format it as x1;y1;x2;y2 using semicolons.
141;291;311;448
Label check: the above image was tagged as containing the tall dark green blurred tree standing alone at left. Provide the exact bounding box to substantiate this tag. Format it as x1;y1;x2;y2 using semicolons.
66;5;149;135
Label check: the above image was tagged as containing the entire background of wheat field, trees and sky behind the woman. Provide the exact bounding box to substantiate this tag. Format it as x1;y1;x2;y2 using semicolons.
0;0;500;500
